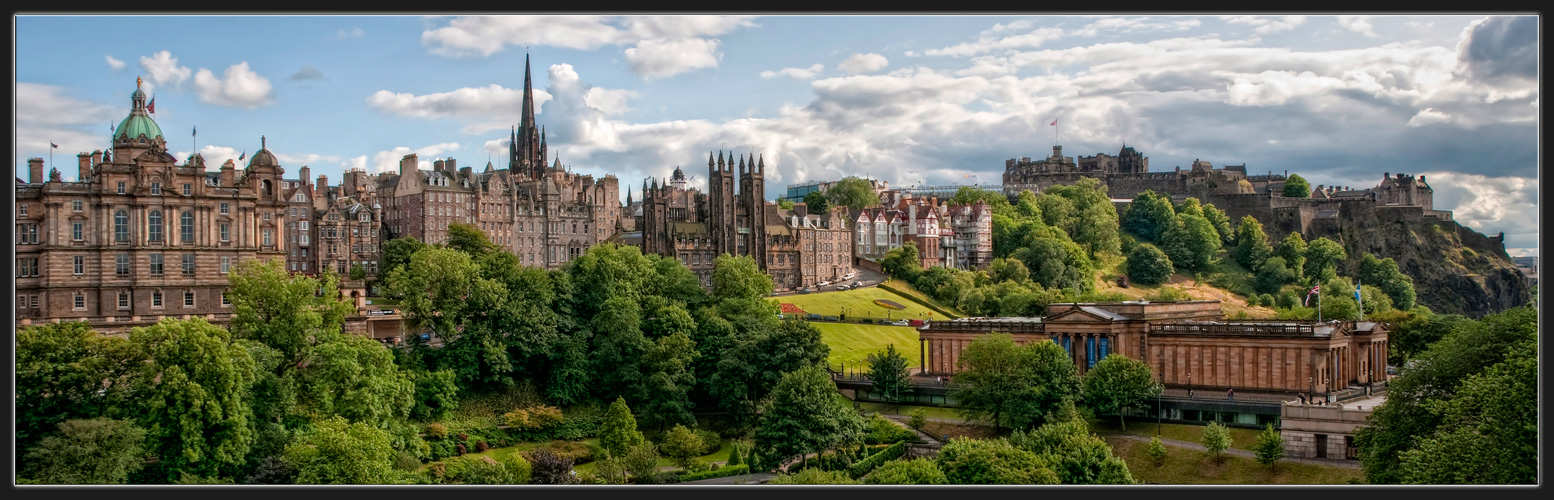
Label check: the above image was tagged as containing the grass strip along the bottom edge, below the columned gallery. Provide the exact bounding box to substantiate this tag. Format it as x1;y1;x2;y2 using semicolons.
1106;437;1364;484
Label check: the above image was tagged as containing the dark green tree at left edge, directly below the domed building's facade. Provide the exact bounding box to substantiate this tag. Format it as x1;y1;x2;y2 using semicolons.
16;321;145;466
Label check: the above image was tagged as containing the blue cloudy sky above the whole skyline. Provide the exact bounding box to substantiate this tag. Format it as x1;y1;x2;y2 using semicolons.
14;16;1538;255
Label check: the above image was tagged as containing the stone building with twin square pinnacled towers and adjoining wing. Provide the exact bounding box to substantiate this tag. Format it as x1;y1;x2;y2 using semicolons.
634;151;853;290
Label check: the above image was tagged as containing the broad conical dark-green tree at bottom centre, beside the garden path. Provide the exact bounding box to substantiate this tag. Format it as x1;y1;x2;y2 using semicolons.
755;365;864;463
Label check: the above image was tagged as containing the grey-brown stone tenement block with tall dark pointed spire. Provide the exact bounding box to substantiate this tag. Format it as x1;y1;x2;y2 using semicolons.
376;57;622;269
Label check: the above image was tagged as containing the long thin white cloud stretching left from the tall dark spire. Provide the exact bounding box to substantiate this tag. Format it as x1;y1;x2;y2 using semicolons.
367;84;552;121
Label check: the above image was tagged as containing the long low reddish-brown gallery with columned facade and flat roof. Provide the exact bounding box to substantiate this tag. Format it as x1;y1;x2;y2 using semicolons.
918;301;1388;394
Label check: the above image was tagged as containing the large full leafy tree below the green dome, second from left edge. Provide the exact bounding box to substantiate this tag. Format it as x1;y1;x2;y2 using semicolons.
129;318;255;480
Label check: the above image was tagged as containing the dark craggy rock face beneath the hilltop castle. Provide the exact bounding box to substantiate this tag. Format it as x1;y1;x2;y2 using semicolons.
1299;200;1532;318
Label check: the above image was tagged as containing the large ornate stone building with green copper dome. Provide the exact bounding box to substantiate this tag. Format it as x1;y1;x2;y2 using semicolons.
16;82;294;334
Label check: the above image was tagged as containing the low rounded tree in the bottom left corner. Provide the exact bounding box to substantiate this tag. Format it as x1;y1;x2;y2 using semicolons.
25;418;146;484
